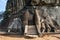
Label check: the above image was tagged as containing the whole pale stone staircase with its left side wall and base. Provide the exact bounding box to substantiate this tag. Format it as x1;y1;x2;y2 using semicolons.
24;25;38;37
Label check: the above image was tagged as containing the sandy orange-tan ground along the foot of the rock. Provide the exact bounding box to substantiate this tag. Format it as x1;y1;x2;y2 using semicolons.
0;34;60;40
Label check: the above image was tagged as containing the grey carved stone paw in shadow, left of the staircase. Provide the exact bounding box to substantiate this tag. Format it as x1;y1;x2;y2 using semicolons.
8;18;23;34
